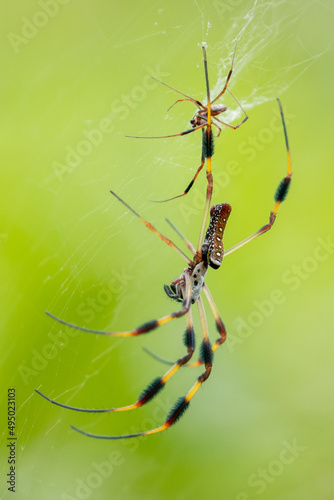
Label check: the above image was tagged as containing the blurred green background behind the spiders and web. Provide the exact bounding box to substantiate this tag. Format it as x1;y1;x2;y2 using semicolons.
0;0;334;500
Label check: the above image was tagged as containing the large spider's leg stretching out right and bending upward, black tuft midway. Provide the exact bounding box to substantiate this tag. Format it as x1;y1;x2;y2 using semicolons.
224;98;292;257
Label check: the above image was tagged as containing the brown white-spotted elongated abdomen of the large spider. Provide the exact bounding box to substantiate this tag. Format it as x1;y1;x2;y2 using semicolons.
202;203;232;269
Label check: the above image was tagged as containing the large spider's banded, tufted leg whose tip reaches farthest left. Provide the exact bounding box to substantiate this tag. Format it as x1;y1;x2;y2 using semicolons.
35;309;195;413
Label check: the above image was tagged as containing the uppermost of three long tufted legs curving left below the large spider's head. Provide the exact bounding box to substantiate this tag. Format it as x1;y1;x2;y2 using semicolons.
45;271;191;337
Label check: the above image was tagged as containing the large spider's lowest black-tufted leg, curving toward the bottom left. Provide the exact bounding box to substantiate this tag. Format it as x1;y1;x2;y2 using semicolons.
72;297;212;439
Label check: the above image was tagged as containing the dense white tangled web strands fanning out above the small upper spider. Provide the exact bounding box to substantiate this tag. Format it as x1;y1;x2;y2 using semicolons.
203;0;330;123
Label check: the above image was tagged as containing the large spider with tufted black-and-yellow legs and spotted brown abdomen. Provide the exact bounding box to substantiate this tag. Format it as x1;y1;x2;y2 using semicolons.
35;99;291;439
